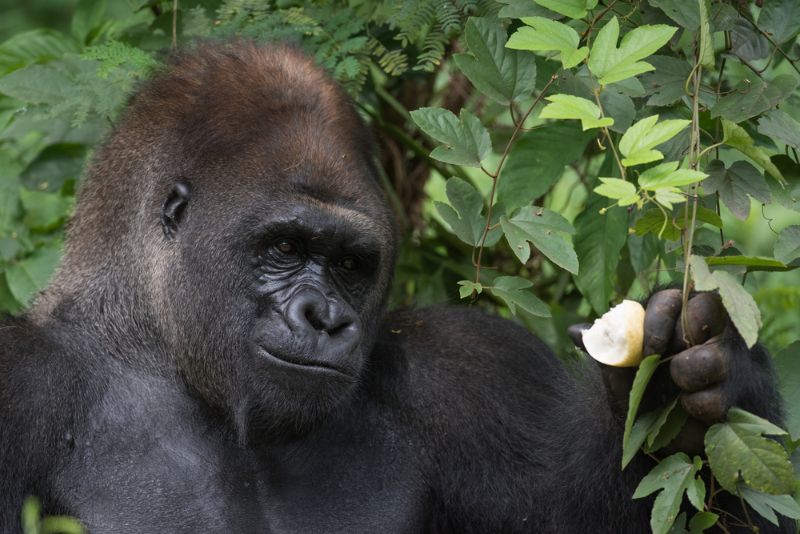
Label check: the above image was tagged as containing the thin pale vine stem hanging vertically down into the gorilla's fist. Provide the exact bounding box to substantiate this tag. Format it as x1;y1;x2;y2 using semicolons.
681;44;703;344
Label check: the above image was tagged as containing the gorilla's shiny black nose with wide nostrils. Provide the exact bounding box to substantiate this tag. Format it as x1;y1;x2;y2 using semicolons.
286;289;358;351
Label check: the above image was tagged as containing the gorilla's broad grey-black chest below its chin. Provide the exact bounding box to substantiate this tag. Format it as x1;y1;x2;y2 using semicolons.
54;386;424;534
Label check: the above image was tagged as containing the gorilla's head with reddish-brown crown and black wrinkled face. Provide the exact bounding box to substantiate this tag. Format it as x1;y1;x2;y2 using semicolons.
40;42;395;439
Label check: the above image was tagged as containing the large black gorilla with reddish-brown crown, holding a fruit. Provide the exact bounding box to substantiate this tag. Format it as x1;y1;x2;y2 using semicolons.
0;42;780;534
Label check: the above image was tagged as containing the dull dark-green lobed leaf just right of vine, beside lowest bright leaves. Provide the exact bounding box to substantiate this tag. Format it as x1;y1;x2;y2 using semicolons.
703;160;772;220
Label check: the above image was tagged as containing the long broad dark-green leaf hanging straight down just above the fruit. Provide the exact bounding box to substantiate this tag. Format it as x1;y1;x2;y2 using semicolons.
573;194;628;314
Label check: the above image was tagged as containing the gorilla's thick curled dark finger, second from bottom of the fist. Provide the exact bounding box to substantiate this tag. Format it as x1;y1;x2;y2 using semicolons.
669;340;728;392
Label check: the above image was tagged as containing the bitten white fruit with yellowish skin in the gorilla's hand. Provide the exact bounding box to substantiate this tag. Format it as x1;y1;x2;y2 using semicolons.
581;300;644;367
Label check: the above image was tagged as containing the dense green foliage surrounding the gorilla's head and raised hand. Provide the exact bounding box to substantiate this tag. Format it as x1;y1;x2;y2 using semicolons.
0;0;800;532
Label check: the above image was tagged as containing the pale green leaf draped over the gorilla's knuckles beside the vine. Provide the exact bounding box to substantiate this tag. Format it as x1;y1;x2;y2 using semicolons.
689;255;761;348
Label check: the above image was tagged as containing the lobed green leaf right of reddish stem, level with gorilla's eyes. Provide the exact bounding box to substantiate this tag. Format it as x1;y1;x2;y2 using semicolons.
500;206;578;274
